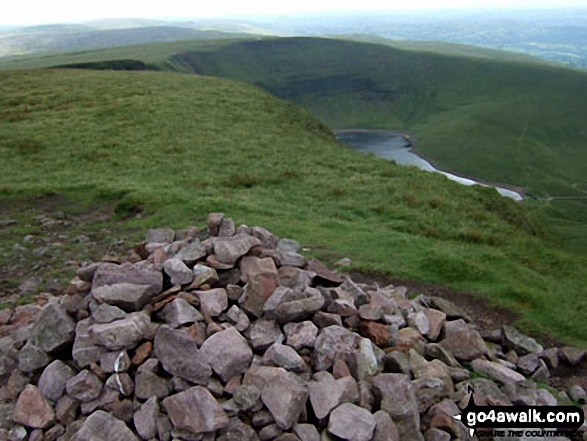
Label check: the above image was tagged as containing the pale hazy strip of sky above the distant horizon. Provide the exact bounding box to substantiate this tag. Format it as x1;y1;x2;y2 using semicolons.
0;0;587;26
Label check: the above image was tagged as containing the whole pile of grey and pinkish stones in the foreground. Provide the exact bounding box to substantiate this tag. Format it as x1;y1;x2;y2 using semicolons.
0;213;585;441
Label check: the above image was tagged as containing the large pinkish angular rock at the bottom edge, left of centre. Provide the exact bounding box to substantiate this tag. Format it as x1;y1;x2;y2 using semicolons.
162;386;228;433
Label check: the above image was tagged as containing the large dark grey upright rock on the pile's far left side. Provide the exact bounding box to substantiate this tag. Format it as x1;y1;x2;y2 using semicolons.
31;303;75;353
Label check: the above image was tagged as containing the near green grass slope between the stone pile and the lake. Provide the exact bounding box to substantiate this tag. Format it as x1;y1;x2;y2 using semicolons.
0;69;587;345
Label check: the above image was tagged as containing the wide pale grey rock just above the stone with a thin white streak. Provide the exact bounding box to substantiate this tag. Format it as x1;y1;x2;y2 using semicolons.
89;312;152;351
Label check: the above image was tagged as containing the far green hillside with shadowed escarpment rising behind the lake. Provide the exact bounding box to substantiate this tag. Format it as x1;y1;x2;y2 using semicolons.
0;38;587;253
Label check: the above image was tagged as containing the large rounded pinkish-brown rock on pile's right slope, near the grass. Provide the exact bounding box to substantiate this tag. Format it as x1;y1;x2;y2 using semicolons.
439;319;487;361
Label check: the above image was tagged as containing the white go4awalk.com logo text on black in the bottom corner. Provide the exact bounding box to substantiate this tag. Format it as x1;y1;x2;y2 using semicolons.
454;384;585;438
